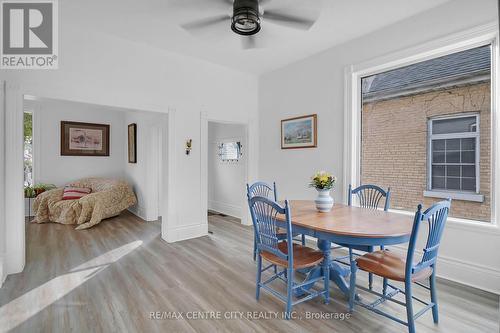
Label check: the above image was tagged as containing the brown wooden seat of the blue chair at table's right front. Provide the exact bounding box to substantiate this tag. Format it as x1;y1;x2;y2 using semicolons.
356;250;432;282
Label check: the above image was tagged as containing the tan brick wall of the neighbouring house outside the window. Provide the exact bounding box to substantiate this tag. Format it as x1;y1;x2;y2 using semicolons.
361;83;491;221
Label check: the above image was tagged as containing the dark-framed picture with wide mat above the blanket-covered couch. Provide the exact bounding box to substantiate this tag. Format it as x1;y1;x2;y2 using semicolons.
61;121;109;156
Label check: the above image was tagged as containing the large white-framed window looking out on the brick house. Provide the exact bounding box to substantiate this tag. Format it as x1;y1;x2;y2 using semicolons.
356;37;492;222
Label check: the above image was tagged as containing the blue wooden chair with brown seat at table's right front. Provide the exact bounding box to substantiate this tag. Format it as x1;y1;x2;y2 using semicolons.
349;199;451;333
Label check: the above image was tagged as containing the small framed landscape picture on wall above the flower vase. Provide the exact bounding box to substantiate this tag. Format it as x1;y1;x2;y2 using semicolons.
281;114;318;149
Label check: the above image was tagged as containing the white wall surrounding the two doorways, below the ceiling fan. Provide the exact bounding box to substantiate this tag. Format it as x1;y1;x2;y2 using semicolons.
0;1;258;273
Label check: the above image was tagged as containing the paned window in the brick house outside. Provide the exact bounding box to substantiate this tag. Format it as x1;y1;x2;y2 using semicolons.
428;114;479;192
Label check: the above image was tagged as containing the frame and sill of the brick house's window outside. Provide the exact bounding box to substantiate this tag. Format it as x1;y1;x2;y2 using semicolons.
424;112;483;198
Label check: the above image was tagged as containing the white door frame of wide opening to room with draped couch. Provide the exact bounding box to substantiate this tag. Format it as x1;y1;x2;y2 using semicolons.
0;87;175;278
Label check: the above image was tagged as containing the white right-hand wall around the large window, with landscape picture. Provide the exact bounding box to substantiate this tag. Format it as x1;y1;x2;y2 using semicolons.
259;0;500;293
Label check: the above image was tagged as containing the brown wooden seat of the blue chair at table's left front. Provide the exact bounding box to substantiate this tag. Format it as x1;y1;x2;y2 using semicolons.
261;241;323;269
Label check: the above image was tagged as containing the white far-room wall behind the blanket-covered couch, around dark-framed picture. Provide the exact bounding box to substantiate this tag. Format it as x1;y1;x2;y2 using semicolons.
26;99;126;186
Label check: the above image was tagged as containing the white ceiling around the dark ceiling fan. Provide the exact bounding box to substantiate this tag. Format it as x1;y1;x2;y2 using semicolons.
64;0;450;74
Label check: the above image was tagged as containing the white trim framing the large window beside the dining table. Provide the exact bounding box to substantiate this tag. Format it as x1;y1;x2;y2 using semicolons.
342;22;500;226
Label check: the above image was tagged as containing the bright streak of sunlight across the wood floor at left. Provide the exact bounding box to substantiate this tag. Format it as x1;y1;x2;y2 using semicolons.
0;240;142;332
